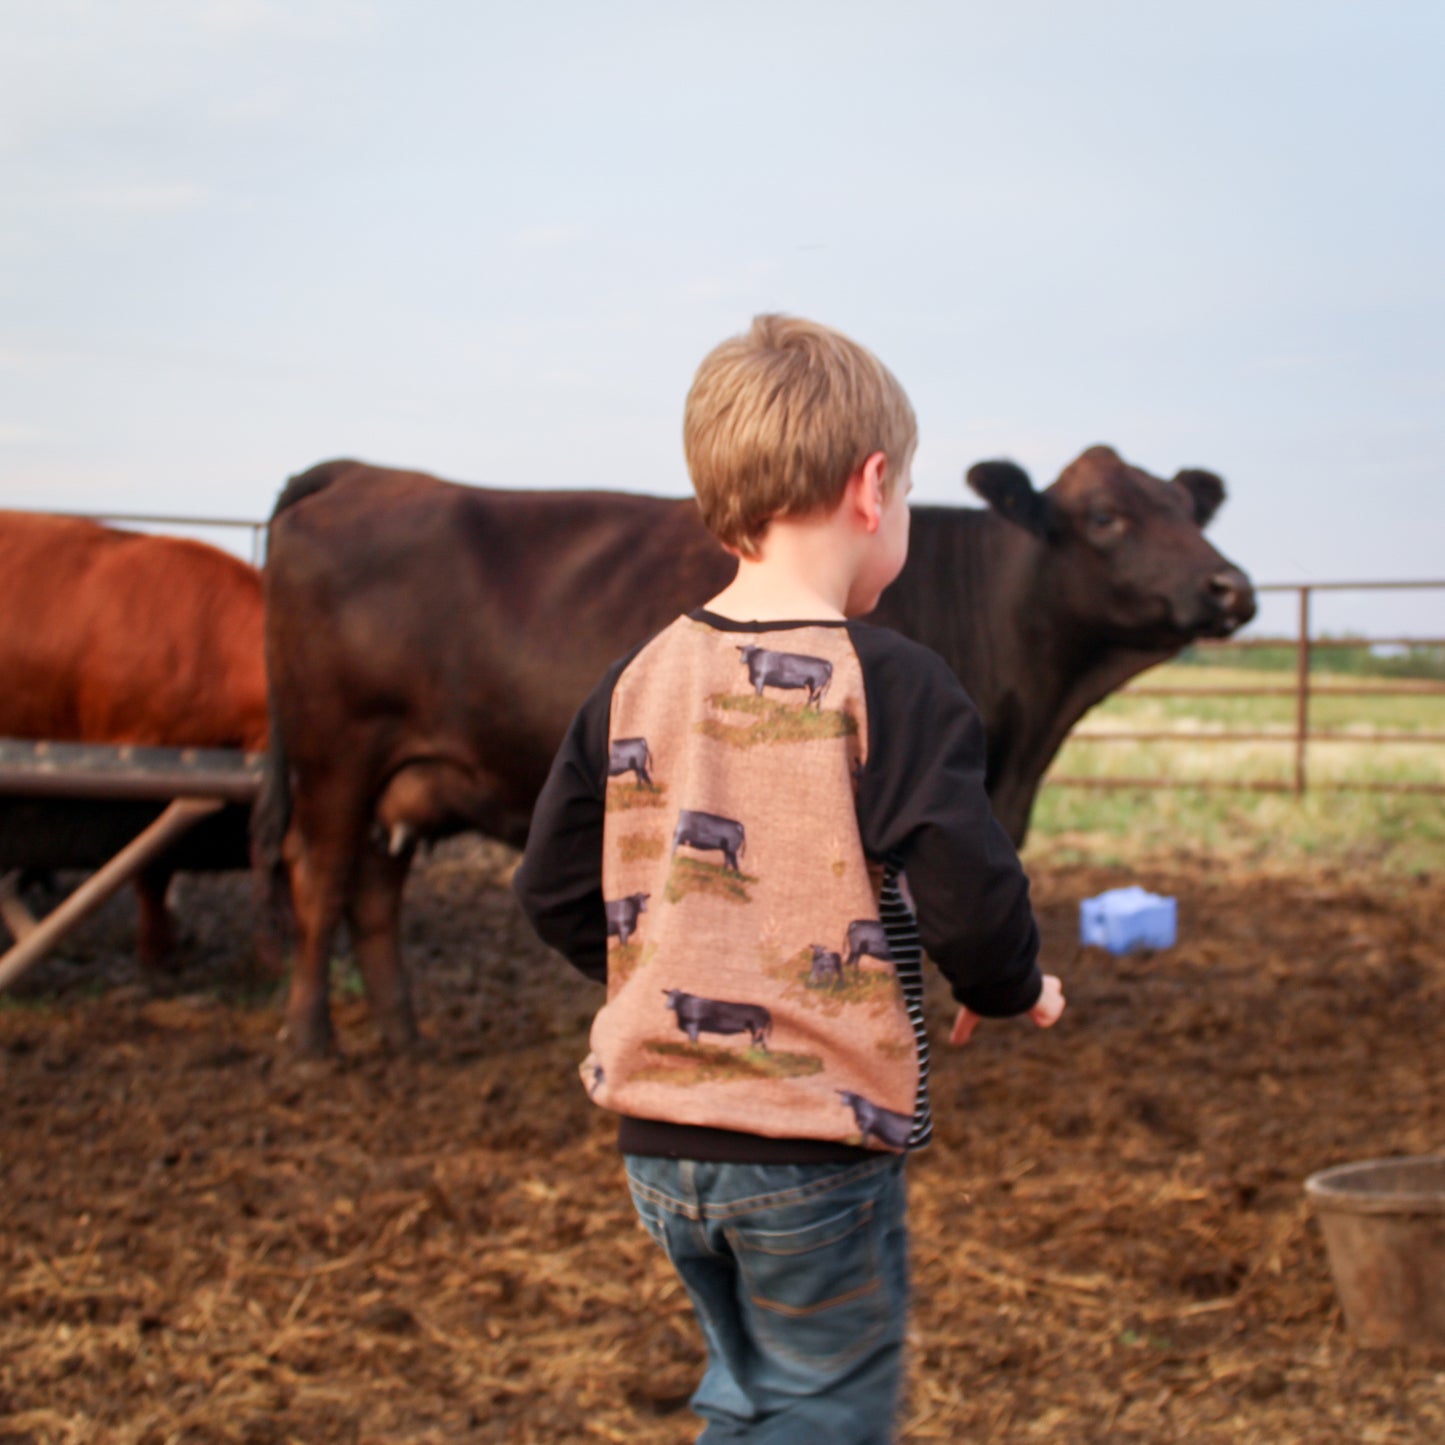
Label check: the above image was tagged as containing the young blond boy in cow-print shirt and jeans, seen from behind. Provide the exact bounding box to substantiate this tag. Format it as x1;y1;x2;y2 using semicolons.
516;316;1064;1445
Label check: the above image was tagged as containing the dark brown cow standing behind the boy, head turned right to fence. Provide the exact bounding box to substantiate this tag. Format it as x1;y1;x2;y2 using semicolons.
253;447;1254;1052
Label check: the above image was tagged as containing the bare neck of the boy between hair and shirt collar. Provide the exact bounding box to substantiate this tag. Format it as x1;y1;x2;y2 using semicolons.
705;519;854;623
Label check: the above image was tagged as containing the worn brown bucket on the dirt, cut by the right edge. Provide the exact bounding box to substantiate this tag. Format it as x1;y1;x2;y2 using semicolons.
1305;1155;1445;1347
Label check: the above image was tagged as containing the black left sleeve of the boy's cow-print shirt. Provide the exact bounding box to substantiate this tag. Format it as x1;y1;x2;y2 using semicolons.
512;656;630;983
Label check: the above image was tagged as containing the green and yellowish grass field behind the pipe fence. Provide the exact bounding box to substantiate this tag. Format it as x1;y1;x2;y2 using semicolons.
1026;663;1445;874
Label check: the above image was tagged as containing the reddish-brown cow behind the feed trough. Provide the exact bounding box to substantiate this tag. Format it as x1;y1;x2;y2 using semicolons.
0;512;267;964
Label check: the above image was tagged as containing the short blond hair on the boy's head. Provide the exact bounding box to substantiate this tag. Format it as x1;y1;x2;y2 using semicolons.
682;316;918;556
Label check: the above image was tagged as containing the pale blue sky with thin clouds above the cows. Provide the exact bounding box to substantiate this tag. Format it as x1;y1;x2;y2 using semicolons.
0;0;1445;634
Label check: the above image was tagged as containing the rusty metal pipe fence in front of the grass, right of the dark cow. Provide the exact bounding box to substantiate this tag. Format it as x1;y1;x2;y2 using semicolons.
1046;581;1445;798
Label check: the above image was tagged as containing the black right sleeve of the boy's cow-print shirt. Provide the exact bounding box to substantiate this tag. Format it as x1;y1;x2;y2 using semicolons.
853;626;1043;1019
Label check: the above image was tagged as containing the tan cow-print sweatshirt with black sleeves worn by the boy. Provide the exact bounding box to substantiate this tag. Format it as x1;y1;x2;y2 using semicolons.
516;608;1042;1163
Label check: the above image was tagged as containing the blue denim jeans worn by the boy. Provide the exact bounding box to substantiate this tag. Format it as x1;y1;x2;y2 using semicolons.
626;1155;907;1445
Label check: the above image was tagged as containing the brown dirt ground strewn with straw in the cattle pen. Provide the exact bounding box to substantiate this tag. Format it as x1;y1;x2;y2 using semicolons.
0;842;1445;1445
